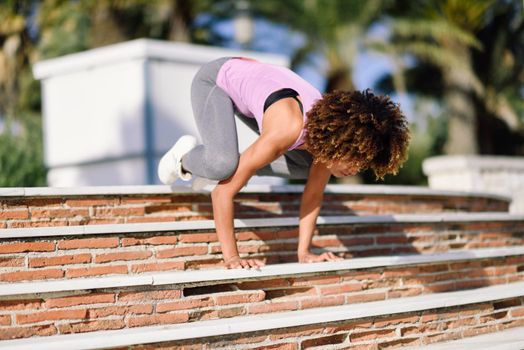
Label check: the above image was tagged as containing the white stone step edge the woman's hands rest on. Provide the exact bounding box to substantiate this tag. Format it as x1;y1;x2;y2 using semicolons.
0;246;524;297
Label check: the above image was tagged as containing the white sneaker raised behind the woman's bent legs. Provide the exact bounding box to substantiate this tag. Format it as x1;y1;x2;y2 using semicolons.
158;135;198;185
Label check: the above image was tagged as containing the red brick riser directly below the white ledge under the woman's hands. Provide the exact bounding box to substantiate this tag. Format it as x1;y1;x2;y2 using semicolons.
0;255;524;340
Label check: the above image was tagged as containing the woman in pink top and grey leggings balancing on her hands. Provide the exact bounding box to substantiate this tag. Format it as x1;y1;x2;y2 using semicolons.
158;57;410;268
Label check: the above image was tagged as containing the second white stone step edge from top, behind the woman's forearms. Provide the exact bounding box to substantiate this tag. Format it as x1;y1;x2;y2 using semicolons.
0;212;524;239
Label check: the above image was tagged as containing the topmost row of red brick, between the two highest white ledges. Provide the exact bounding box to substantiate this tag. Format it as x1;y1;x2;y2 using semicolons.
0;193;509;227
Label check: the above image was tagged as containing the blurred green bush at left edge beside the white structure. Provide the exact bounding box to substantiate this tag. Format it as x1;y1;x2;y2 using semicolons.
0;116;46;187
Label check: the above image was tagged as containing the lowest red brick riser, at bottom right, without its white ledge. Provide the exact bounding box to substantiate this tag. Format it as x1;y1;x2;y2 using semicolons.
91;298;524;350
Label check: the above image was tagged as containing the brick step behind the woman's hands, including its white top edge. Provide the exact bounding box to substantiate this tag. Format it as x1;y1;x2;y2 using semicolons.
0;213;524;283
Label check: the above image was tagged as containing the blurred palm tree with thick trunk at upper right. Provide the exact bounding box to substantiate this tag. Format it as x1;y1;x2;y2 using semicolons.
374;0;524;154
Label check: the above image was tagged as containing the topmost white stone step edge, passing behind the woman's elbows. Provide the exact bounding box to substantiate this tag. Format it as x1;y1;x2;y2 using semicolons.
0;184;511;201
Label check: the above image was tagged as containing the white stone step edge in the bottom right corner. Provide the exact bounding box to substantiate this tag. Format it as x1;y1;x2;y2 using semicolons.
402;327;524;350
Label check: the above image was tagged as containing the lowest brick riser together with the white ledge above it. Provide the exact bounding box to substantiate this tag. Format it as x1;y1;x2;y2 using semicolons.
0;282;524;350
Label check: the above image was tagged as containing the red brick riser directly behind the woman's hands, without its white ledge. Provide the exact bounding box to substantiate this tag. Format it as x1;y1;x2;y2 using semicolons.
0;221;524;283
